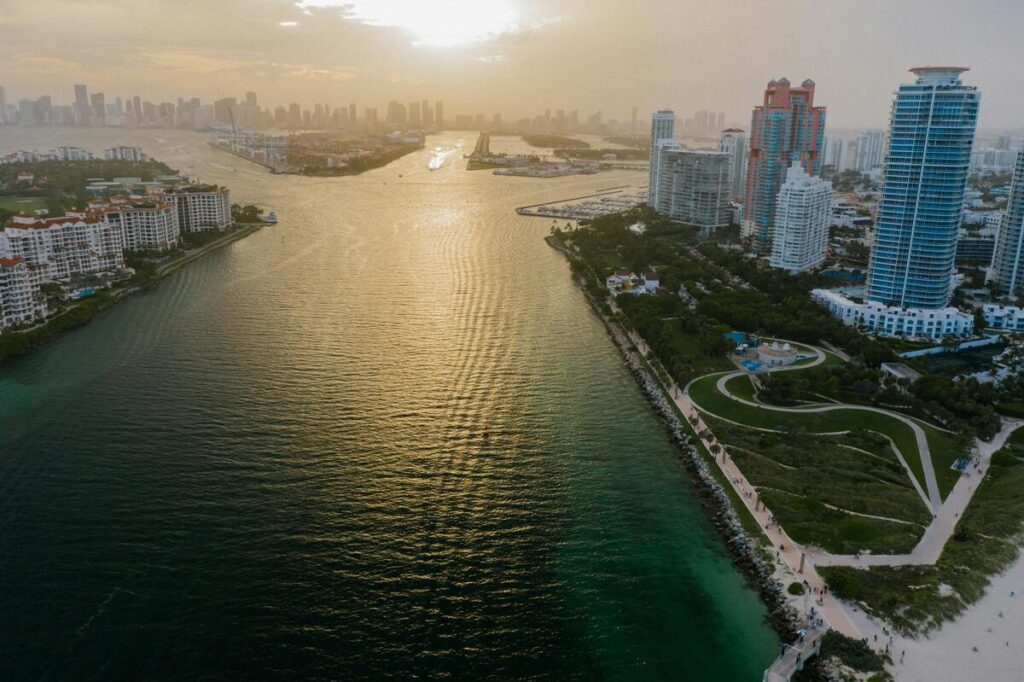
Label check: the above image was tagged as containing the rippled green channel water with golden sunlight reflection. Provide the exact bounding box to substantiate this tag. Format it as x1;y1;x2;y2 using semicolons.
0;129;775;680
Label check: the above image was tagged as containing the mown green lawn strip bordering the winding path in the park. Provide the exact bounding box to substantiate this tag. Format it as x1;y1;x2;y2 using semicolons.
690;375;958;497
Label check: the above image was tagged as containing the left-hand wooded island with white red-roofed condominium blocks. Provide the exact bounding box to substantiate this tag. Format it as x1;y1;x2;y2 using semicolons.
0;151;265;363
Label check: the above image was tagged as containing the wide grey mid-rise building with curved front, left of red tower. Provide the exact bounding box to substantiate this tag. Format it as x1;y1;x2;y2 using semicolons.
653;145;732;227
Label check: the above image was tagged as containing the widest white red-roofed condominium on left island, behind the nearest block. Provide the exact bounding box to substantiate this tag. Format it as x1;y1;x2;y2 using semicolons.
4;214;125;282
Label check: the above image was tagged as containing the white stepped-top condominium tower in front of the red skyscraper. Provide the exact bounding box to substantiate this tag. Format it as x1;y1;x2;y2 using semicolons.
771;162;833;272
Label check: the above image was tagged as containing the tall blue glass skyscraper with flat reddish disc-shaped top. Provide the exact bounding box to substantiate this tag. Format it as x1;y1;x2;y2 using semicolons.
867;67;981;308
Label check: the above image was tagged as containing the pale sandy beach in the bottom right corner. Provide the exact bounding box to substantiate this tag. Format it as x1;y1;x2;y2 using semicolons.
893;558;1024;682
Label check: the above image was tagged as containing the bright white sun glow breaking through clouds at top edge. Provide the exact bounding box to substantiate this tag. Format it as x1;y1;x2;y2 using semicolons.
299;0;519;47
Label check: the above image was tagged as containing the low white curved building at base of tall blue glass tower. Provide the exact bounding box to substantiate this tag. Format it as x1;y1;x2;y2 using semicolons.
811;289;974;339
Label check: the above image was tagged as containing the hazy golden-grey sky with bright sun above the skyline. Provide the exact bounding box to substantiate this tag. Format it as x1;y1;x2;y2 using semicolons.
0;0;1024;128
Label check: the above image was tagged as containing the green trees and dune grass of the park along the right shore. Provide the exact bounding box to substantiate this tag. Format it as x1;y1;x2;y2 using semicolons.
546;208;1024;680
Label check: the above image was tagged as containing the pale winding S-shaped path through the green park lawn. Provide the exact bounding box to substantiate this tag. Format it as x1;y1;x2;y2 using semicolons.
683;341;942;515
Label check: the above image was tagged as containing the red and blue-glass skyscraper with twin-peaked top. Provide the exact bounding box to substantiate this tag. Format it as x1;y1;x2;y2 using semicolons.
743;78;825;245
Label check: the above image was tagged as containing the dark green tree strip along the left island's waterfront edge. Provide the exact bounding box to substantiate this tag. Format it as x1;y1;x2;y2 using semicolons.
0;206;266;366
